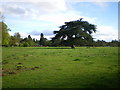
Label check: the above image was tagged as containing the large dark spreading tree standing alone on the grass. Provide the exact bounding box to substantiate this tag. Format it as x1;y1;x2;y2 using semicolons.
52;18;96;47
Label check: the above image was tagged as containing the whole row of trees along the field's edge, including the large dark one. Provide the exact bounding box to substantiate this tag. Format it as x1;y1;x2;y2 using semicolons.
0;18;119;48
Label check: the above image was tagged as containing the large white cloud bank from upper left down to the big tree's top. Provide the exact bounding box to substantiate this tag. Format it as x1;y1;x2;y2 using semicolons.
2;0;96;25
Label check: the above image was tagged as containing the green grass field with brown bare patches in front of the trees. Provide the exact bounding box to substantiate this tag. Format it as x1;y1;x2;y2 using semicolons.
2;47;119;88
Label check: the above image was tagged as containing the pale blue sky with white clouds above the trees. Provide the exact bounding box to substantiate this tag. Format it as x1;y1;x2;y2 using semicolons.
0;0;118;41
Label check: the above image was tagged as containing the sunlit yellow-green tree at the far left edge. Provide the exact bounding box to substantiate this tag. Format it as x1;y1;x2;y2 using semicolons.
0;22;10;45
